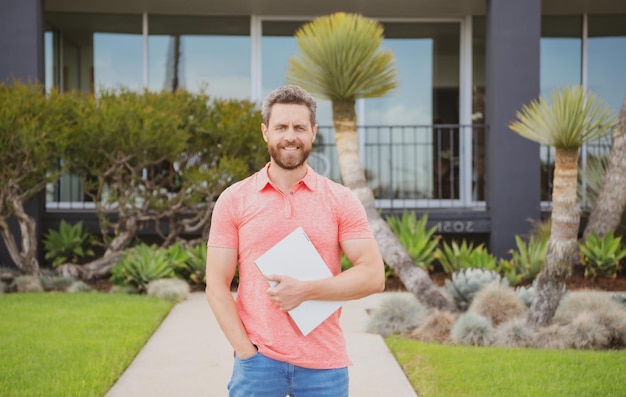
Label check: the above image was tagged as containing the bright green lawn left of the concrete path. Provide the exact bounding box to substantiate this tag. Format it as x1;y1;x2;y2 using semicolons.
0;293;172;397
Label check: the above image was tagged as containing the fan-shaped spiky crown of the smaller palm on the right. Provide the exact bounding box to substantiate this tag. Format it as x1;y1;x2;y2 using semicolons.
509;86;617;148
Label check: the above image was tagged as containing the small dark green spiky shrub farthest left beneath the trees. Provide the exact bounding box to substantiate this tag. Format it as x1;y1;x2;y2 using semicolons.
43;220;94;267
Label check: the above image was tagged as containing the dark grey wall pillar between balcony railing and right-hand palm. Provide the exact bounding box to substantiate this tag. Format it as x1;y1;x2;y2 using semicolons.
485;0;541;257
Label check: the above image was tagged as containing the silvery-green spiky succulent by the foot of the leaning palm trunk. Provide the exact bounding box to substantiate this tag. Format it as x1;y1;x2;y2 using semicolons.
444;268;509;310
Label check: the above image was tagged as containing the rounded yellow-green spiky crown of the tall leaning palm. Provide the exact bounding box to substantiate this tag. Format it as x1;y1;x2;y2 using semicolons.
286;12;397;101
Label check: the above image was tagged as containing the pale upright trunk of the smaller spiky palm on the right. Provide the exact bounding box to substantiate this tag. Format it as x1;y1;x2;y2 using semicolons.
527;148;580;325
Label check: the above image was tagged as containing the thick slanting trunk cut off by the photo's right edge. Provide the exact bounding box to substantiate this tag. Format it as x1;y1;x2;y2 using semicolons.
583;99;626;240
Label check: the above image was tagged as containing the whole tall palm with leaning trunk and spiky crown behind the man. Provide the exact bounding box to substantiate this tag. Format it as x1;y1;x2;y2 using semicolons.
286;13;456;312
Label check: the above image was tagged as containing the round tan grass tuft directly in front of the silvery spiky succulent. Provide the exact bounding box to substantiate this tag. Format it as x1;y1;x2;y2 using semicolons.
468;283;526;327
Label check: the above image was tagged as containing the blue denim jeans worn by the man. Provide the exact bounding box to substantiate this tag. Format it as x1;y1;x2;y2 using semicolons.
228;353;348;397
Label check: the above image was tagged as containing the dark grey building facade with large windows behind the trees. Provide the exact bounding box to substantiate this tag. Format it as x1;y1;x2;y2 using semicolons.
0;0;626;264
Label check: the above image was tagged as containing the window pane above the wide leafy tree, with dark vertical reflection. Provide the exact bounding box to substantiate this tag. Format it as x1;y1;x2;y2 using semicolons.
148;16;250;99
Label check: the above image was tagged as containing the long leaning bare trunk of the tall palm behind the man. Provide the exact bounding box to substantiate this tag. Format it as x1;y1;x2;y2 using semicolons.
333;101;458;313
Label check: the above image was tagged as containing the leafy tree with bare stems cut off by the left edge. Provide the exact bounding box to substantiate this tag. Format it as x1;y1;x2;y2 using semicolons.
0;81;80;275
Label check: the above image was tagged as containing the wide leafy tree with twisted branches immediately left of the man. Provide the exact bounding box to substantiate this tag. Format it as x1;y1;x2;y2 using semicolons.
59;89;267;278
